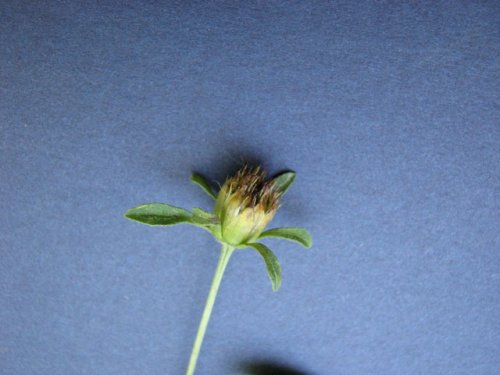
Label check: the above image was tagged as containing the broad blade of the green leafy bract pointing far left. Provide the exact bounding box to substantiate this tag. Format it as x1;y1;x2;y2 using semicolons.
125;203;192;225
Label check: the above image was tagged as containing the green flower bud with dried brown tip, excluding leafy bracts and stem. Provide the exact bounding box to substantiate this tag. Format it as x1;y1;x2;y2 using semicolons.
214;166;281;246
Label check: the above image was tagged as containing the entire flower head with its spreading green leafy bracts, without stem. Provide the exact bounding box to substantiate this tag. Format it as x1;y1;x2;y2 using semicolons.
125;166;312;291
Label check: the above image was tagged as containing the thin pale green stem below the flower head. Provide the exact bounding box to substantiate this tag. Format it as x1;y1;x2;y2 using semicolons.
186;245;234;375
